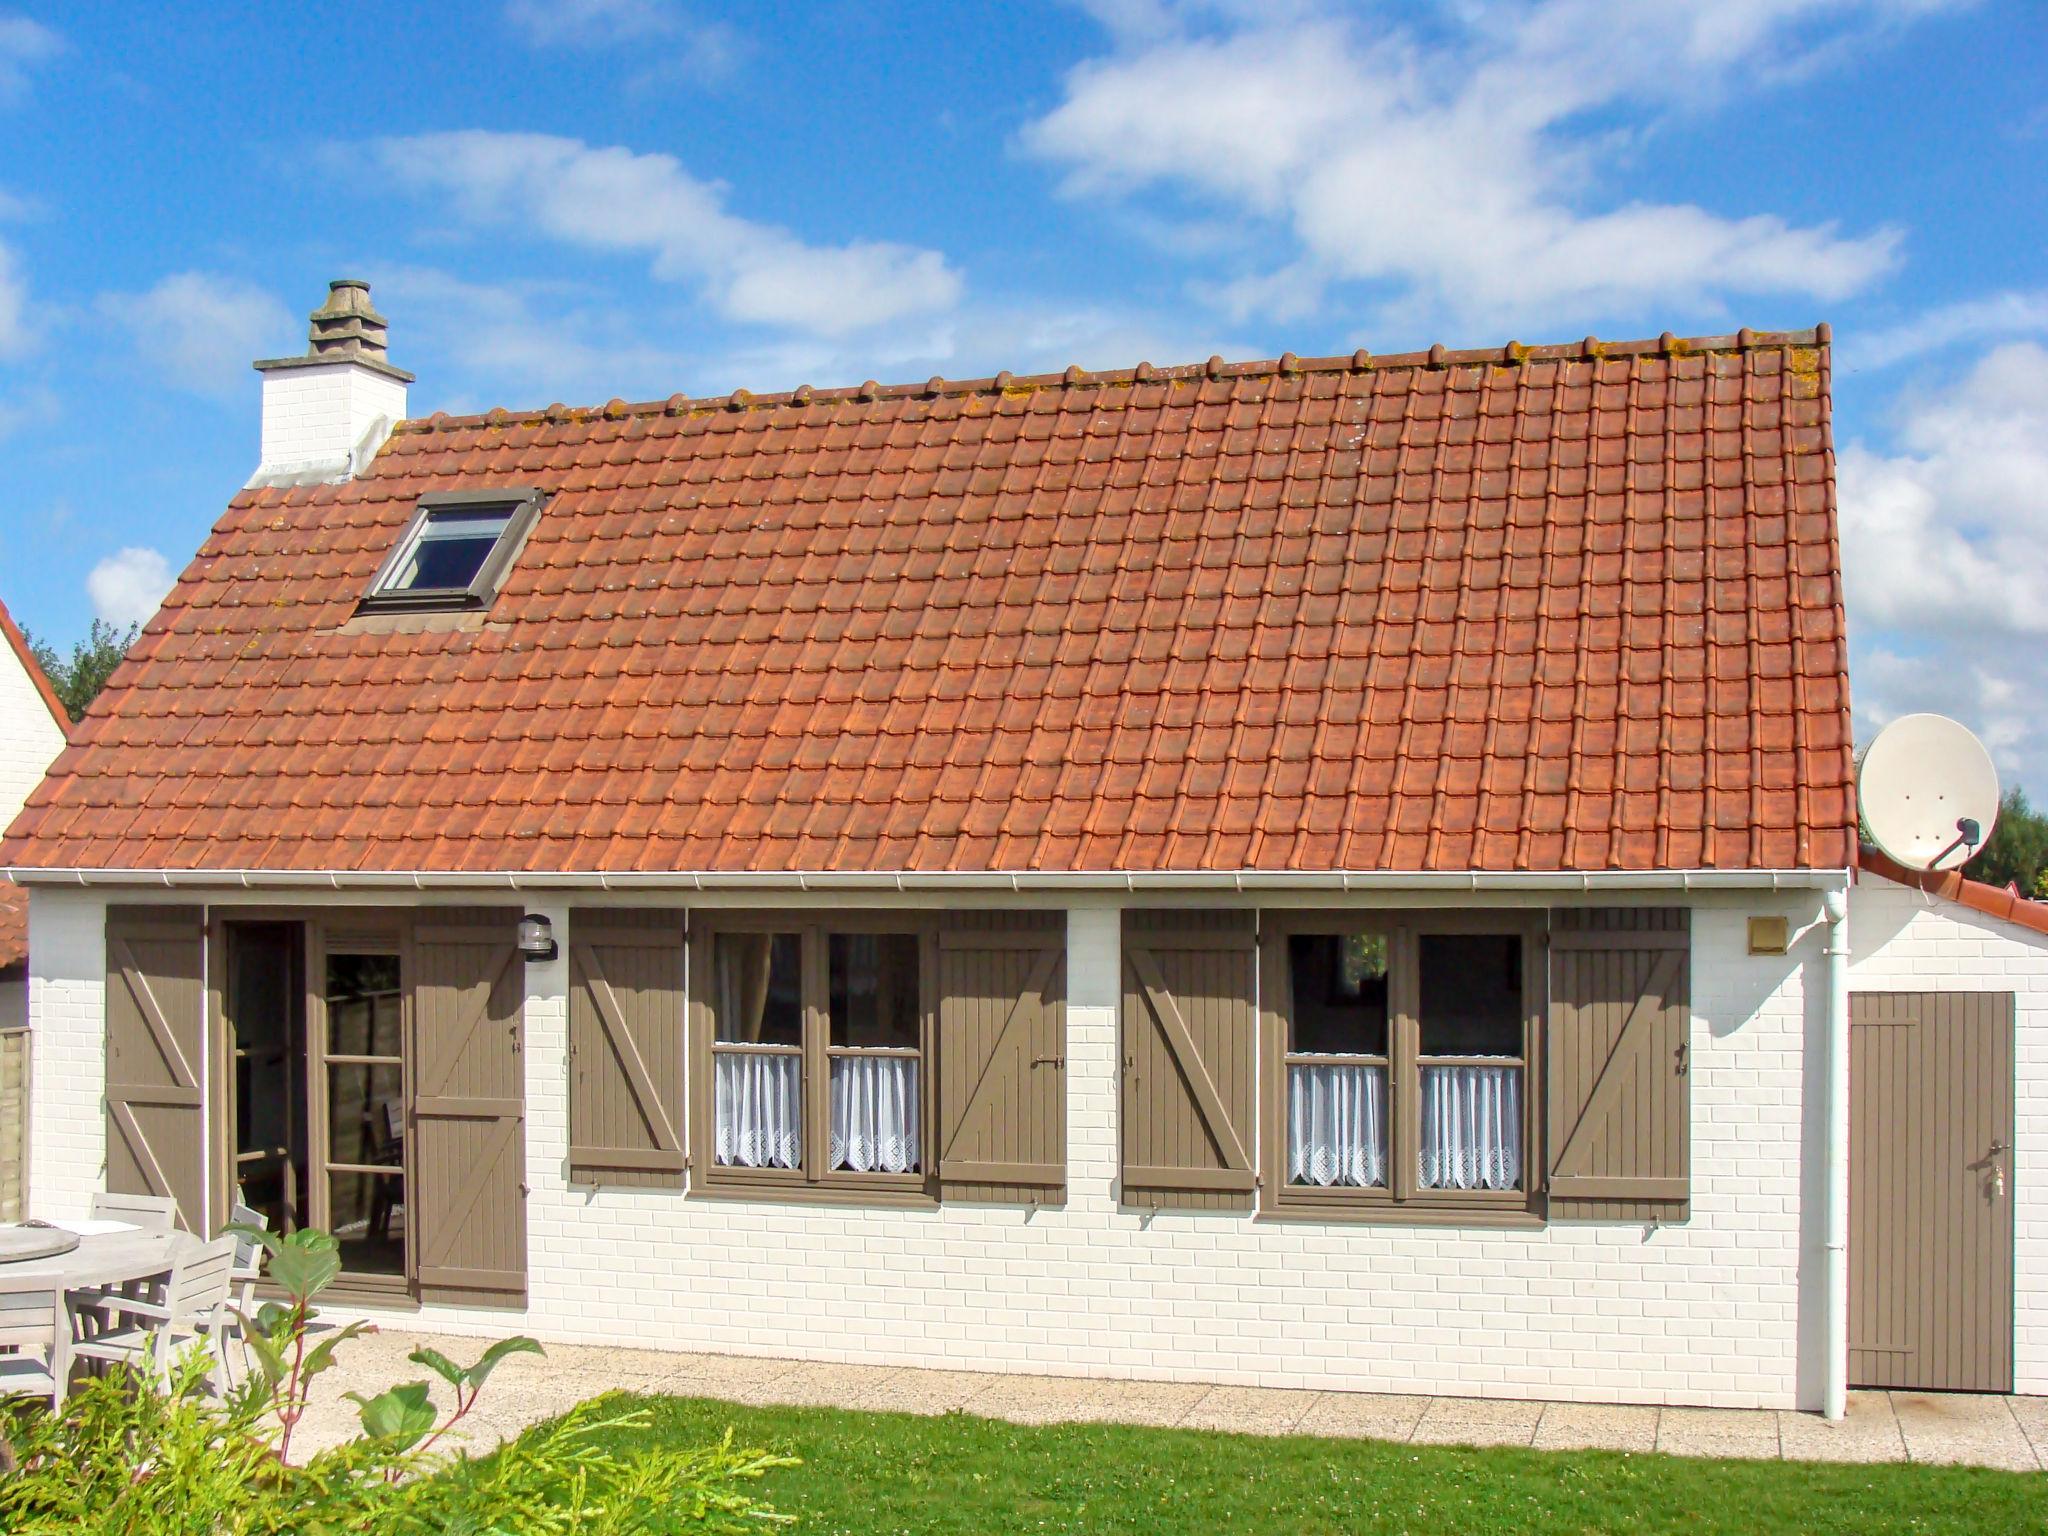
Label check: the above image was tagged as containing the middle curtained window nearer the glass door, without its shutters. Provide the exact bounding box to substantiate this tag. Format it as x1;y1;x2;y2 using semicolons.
694;915;934;1192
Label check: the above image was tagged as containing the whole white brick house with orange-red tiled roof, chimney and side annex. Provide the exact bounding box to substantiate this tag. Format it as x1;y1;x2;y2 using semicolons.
0;283;2048;1413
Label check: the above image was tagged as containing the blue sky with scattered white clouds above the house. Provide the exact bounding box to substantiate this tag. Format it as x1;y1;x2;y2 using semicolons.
0;0;2048;795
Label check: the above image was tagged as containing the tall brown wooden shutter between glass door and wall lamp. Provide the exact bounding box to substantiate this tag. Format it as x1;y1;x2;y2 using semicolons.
412;907;526;1307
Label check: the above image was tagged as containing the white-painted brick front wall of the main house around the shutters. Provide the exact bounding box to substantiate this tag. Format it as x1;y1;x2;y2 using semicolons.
33;891;1821;1407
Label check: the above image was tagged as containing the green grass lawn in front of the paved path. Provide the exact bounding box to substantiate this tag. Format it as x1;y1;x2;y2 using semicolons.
581;1397;2048;1536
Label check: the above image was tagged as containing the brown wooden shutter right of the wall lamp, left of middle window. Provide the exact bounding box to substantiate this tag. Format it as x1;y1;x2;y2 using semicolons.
569;909;684;1188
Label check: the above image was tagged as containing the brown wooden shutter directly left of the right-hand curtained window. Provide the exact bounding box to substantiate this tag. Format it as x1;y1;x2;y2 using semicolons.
1122;911;1257;1210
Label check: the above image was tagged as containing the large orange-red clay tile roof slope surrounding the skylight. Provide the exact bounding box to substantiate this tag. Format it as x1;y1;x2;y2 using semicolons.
0;330;1855;872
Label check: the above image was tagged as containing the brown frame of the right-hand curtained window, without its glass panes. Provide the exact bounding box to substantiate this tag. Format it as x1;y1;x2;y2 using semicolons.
1260;907;1550;1225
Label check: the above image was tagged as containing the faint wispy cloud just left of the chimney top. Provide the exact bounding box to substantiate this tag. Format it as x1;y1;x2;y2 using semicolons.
100;272;303;395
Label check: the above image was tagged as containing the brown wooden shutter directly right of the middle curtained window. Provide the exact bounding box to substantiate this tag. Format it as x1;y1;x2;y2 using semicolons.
932;911;1067;1204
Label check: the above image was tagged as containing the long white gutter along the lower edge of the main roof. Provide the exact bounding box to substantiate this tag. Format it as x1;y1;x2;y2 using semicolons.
0;866;1849;895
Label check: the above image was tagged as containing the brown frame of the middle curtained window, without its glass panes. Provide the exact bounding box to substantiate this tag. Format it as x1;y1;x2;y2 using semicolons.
686;909;938;1206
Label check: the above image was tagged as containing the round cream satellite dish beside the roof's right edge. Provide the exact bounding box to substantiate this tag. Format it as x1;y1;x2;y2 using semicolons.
1855;715;1999;868
